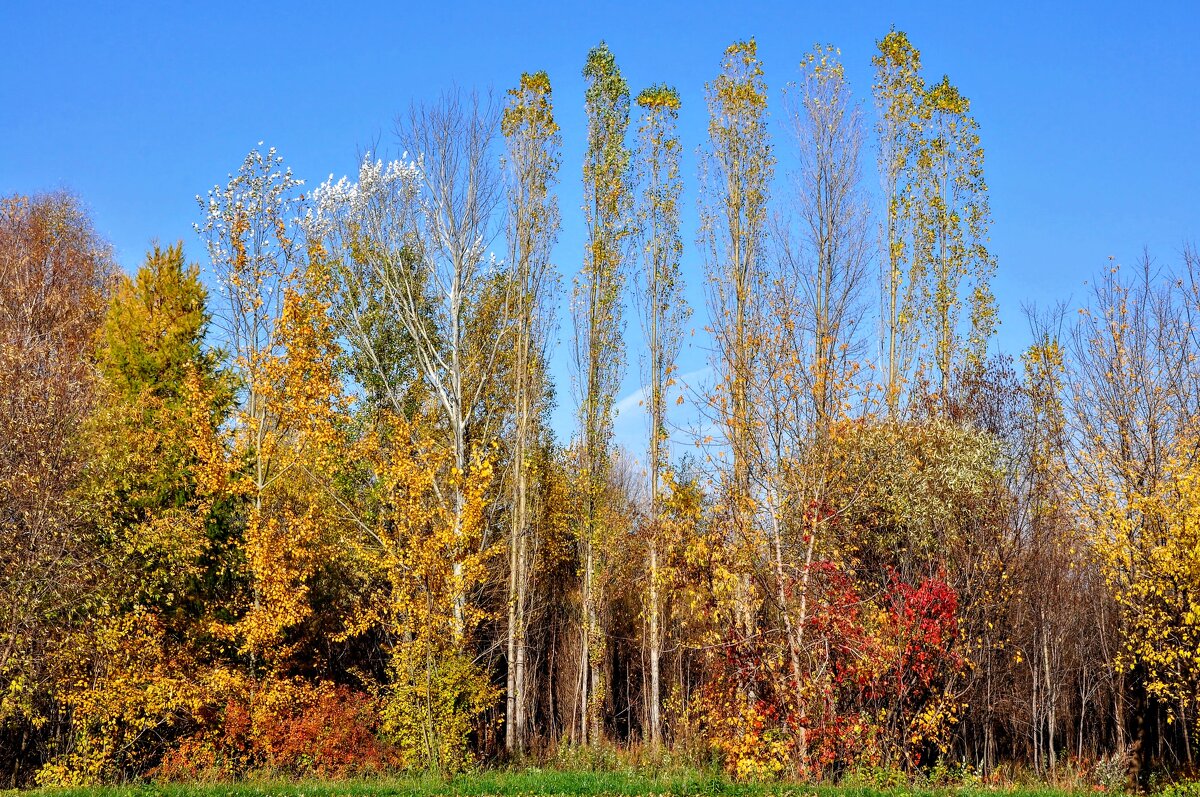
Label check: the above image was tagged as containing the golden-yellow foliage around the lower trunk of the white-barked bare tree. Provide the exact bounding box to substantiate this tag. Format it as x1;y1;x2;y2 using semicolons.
342;415;497;772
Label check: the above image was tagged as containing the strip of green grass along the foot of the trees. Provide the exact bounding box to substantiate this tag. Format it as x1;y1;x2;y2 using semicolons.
25;769;1099;797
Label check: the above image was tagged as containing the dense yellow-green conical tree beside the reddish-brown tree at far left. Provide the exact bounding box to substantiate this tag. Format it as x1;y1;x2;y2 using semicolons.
82;245;230;613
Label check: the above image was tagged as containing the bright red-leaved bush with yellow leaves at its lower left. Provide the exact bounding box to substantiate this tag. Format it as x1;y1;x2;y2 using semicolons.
704;562;966;777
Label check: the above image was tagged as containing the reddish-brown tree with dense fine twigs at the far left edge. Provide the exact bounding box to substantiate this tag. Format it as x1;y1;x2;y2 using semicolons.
0;193;115;785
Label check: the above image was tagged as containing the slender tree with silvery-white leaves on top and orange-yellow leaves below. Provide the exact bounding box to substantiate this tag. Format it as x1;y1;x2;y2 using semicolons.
197;149;340;672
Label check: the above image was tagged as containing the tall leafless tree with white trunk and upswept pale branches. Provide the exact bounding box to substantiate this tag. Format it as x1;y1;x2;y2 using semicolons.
393;94;510;645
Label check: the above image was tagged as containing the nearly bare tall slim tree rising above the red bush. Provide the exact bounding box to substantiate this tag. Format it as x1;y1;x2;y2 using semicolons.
755;47;871;759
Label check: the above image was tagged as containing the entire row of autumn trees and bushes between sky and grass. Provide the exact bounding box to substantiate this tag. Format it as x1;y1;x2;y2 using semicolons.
0;29;1200;789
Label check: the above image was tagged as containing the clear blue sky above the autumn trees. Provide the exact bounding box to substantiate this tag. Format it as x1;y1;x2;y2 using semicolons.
0;0;1200;442
